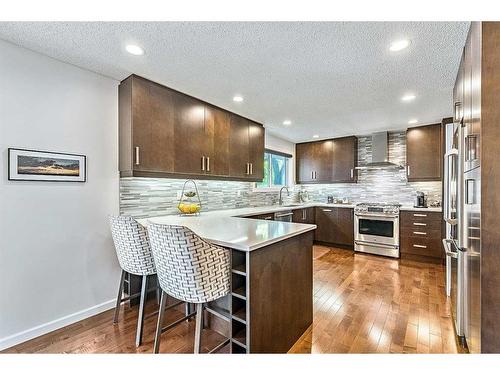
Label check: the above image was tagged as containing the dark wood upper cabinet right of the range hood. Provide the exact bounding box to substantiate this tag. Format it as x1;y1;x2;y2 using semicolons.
406;124;443;182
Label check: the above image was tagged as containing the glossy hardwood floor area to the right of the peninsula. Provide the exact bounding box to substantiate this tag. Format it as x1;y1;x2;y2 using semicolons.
290;246;460;353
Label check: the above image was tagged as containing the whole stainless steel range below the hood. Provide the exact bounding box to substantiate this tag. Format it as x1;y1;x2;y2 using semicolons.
354;203;400;258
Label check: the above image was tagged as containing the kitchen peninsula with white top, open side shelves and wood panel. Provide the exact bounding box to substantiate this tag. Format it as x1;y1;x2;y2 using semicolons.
139;211;316;353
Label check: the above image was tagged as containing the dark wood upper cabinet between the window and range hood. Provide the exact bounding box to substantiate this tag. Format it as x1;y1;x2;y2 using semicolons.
295;136;358;183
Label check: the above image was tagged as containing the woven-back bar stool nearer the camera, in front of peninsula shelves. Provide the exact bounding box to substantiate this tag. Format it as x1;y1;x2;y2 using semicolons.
148;224;230;353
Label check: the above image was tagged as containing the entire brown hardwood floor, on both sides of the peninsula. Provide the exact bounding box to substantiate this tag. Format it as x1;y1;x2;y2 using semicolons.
4;246;460;353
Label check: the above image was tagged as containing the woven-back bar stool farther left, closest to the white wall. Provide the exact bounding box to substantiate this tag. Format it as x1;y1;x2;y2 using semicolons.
109;216;158;347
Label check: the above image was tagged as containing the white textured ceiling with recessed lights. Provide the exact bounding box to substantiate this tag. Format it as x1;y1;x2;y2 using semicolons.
0;22;469;141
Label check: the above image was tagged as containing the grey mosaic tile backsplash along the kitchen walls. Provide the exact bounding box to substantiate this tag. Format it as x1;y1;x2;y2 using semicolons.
120;132;441;217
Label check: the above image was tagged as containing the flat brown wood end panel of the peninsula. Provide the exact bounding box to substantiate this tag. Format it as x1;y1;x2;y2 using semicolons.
247;232;313;353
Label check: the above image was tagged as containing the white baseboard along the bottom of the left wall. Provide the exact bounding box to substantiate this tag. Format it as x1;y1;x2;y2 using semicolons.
0;299;116;350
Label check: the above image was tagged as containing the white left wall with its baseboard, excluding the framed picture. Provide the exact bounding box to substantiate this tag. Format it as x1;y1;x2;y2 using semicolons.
0;41;119;349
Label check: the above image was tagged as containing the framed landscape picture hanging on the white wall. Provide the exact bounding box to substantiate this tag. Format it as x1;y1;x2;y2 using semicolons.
9;148;87;182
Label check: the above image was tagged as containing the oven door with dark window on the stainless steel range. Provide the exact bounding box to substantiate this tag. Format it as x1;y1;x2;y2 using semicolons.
354;213;399;246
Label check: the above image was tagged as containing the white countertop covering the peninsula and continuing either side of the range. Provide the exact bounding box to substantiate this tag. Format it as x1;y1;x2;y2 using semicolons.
138;202;441;251
